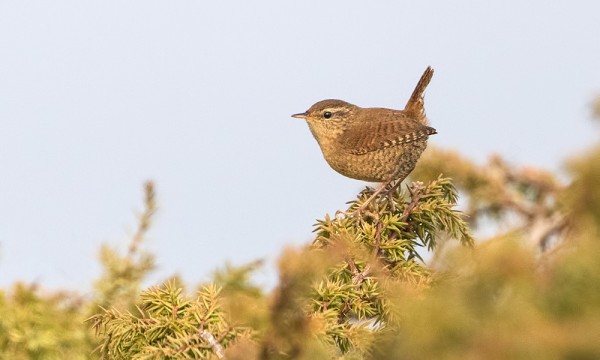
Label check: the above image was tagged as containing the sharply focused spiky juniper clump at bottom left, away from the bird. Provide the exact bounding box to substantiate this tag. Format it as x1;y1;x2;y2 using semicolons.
89;283;246;359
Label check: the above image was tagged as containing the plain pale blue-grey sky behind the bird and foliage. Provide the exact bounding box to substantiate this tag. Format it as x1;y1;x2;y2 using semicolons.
0;0;600;291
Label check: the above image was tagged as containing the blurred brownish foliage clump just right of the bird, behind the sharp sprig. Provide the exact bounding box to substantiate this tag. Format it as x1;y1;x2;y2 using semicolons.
413;148;569;252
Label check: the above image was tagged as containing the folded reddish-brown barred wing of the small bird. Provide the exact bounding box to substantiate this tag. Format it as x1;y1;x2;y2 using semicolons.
342;116;437;155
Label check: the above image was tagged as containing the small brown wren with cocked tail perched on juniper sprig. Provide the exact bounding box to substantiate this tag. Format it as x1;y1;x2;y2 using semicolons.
292;67;437;201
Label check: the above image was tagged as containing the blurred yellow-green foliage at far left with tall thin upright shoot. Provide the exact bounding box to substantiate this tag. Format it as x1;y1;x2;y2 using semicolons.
0;182;156;360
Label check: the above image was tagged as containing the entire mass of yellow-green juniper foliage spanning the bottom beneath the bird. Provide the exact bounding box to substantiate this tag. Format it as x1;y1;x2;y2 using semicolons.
0;95;600;360
